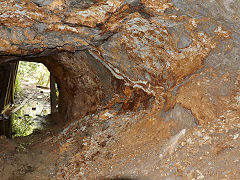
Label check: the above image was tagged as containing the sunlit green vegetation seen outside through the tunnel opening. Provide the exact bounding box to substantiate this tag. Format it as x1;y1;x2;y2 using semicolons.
11;61;50;137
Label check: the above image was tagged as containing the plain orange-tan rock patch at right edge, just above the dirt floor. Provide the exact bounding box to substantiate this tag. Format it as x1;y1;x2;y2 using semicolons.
176;69;239;124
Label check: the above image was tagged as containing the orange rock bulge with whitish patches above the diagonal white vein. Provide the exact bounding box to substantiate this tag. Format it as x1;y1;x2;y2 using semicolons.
101;13;216;94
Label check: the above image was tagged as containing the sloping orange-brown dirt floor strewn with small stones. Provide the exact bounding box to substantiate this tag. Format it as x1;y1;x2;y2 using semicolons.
0;105;240;180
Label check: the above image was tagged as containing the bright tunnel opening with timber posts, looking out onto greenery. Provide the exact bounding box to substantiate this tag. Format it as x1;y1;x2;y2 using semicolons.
0;61;59;138
